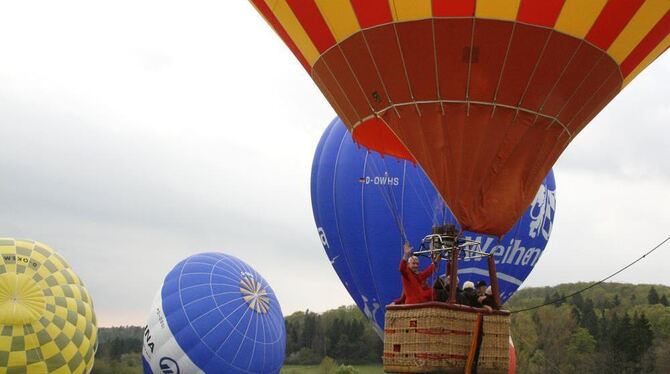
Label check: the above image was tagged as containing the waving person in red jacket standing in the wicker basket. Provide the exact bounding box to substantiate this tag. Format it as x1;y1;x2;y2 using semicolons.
400;243;440;304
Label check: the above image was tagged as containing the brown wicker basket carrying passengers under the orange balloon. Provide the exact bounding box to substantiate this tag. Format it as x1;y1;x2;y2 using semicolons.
383;302;510;374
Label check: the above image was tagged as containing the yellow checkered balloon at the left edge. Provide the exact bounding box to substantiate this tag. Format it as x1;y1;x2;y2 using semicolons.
0;238;98;374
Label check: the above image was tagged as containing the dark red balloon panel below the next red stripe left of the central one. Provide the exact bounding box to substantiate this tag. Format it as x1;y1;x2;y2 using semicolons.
363;24;412;103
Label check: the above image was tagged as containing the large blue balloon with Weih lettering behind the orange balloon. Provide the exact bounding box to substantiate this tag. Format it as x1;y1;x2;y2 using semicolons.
312;118;556;332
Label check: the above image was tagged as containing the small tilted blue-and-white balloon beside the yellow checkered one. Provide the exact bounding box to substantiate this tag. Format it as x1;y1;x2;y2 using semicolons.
142;253;286;374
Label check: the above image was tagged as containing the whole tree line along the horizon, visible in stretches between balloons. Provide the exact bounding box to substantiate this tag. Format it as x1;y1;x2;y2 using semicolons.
93;283;670;374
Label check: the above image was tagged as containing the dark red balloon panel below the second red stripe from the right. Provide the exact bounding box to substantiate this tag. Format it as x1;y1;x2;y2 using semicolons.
540;43;603;116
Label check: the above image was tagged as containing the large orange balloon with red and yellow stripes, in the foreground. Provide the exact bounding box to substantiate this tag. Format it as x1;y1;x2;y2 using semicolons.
251;0;670;235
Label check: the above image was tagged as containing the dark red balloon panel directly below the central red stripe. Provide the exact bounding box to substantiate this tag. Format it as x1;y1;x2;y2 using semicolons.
434;19;473;100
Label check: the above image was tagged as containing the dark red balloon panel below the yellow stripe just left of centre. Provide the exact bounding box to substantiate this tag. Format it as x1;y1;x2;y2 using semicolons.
396;20;437;101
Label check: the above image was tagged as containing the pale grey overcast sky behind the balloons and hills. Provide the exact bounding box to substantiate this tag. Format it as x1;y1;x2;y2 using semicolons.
0;0;670;326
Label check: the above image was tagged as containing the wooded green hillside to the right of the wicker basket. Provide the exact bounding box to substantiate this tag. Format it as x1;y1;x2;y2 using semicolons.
505;283;670;374
